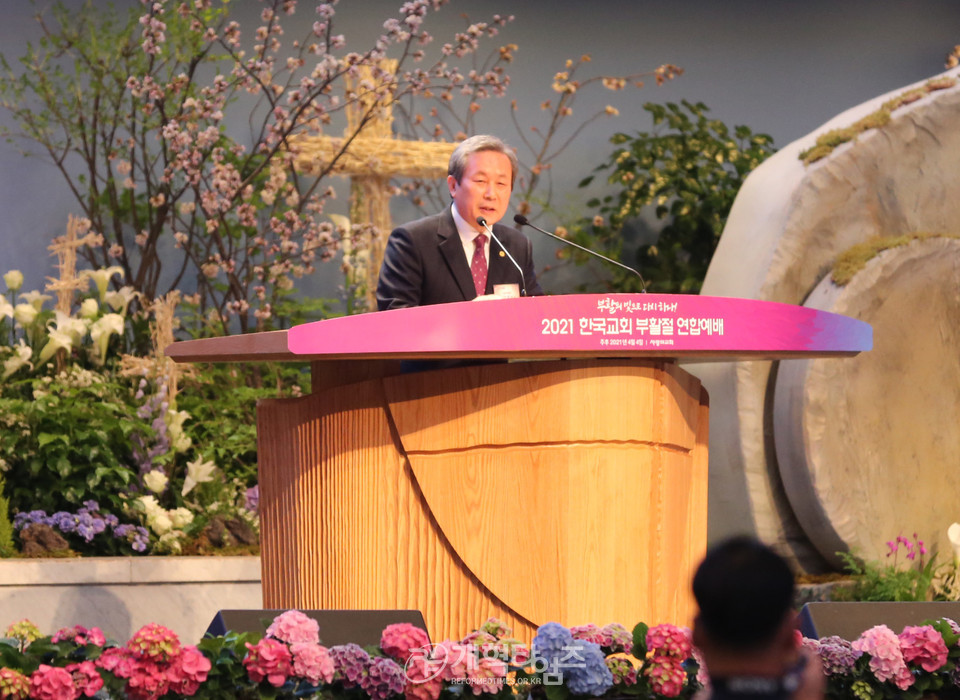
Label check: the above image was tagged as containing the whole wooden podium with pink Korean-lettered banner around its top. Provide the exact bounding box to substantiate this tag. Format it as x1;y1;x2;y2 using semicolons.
167;295;871;640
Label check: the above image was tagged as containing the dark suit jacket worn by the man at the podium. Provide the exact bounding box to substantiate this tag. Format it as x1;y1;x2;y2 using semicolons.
377;209;543;311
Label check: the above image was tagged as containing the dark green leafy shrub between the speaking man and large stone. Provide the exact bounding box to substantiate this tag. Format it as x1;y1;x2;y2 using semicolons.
563;100;775;293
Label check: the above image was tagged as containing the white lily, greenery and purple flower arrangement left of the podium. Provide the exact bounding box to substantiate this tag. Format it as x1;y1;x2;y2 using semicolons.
0;268;275;556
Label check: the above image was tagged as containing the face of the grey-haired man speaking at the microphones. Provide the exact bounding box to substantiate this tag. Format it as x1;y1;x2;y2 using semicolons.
447;151;513;226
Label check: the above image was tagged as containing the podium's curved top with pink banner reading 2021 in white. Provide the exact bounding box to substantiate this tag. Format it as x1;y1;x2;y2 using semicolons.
165;294;873;362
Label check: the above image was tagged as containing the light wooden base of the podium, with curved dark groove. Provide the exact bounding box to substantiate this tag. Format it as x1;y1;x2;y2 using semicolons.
258;360;708;641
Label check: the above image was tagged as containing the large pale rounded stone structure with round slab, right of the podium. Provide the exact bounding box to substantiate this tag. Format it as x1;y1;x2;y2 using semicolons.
689;71;960;570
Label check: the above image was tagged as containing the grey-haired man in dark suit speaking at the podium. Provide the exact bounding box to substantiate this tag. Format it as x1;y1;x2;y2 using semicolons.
377;135;543;311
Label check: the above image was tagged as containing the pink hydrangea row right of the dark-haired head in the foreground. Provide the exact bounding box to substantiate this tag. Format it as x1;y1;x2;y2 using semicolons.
803;618;960;700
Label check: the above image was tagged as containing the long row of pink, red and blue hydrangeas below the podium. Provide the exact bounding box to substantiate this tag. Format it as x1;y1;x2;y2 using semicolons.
0;610;701;700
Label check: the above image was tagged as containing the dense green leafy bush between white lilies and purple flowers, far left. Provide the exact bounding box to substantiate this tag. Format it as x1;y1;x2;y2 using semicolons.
0;369;146;513
